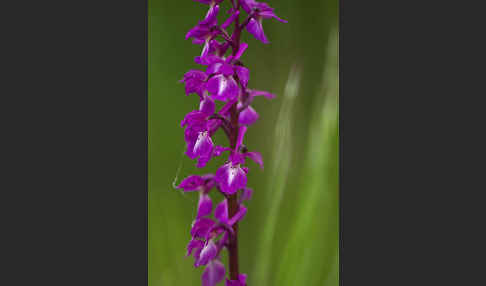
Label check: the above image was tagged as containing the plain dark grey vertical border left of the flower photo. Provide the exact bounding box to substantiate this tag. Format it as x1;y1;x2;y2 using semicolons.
0;0;148;286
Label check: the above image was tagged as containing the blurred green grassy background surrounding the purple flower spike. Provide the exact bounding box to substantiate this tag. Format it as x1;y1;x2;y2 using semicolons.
148;0;339;286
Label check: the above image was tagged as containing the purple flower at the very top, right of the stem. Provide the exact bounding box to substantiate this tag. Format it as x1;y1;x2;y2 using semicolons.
240;0;287;44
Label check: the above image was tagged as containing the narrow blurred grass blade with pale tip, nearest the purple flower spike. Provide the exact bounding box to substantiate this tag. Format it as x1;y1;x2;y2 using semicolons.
250;66;300;285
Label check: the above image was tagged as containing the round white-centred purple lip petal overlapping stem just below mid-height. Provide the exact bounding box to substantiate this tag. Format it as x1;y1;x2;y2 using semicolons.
215;162;247;195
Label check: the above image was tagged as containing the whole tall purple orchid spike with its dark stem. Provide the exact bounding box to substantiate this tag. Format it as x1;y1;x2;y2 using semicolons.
178;0;287;286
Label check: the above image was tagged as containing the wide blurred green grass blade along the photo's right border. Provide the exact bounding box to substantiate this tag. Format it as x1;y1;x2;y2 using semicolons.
274;27;339;286
